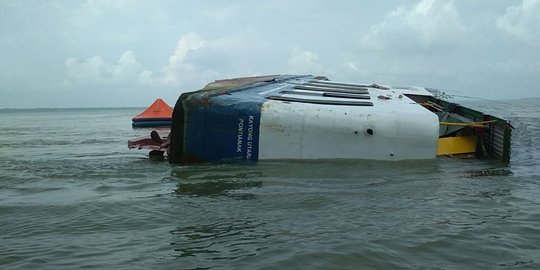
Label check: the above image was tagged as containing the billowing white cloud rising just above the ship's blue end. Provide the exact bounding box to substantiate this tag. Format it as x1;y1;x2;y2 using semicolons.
138;31;276;87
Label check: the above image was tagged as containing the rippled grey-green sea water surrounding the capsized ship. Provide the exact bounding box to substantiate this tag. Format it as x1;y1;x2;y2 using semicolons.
0;99;540;269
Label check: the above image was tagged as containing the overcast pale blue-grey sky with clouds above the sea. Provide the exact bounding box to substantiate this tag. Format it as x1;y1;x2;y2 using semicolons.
0;0;540;108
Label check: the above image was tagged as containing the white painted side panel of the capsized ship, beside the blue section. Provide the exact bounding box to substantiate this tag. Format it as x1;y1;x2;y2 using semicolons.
259;94;439;160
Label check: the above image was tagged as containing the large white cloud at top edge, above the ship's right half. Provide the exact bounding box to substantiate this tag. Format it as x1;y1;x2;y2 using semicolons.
360;0;468;51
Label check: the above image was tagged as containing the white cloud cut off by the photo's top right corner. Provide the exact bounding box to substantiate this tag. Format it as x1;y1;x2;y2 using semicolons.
497;0;540;45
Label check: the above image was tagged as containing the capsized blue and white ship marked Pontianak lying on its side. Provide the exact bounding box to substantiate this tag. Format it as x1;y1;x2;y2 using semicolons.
130;75;512;163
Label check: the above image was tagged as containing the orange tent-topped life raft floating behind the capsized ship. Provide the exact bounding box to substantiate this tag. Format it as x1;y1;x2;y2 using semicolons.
131;98;173;127
